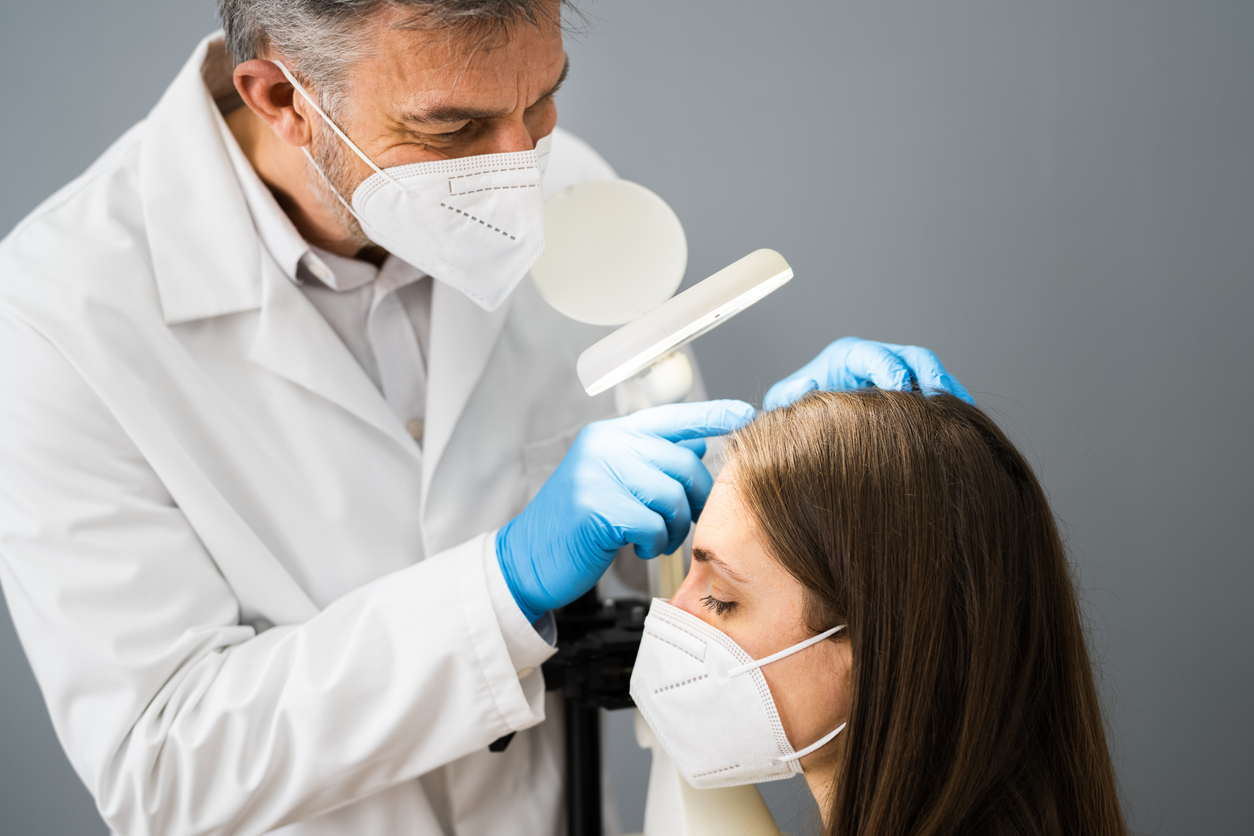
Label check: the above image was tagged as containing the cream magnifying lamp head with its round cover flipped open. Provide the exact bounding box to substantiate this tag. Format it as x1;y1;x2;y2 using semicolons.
532;180;793;412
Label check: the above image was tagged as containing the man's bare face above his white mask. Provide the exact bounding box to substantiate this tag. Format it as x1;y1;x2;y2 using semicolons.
303;8;566;176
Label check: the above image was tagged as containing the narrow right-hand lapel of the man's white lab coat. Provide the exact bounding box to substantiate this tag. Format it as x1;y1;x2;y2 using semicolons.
423;282;512;504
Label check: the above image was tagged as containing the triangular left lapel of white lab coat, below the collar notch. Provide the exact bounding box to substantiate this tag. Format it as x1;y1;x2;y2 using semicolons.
248;257;419;456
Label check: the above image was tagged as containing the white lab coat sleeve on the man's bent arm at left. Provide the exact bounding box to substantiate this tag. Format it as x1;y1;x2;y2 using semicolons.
0;308;553;836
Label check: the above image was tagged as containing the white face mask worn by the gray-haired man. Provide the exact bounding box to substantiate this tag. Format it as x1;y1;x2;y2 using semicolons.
275;61;552;311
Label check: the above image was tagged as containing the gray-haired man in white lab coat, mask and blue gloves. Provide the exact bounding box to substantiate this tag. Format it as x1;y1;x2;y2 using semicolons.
0;0;957;836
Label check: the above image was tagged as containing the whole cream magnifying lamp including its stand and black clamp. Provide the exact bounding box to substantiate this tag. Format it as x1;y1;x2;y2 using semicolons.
532;180;793;836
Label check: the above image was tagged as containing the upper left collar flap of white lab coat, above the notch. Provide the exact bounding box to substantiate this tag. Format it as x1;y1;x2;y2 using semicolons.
139;33;262;325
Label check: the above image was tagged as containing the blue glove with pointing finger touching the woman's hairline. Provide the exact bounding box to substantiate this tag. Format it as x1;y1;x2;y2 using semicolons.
497;401;754;622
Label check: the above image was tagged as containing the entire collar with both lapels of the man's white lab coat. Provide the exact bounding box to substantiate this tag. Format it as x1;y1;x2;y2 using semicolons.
139;33;510;476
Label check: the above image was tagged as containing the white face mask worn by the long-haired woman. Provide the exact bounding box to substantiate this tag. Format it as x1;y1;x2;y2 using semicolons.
631;598;845;790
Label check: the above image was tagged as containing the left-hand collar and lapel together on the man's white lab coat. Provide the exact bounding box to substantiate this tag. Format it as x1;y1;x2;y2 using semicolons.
140;34;418;455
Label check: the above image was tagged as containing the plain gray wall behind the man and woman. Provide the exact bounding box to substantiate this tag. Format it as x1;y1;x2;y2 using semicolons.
0;0;1254;836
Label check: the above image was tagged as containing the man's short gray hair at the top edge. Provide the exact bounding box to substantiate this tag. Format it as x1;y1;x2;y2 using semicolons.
218;0;566;110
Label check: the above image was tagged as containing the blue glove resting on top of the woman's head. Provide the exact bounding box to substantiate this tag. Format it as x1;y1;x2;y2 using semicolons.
762;337;974;410
